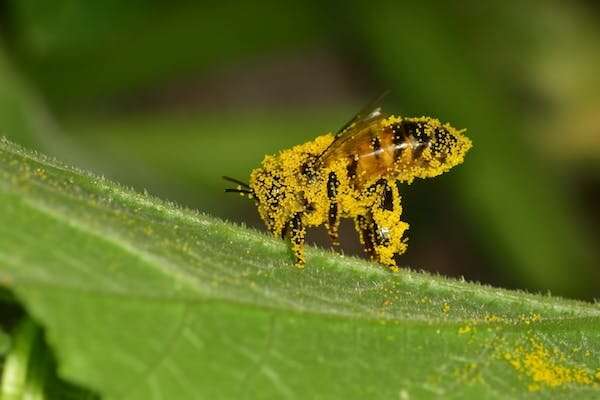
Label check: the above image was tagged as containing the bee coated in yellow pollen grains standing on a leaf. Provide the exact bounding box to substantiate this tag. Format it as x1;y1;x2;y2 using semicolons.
224;97;472;271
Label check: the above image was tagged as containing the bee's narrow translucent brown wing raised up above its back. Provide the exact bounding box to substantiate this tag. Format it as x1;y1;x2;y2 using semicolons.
317;90;389;163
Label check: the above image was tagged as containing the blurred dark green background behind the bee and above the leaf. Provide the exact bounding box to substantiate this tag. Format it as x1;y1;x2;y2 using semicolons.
0;0;600;299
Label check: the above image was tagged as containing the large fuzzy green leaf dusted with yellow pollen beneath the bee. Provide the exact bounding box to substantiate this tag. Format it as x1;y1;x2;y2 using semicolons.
0;137;600;399
